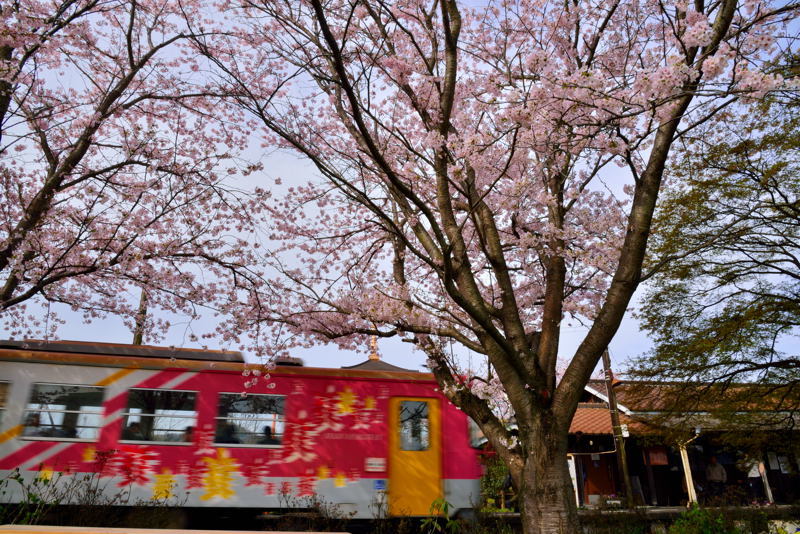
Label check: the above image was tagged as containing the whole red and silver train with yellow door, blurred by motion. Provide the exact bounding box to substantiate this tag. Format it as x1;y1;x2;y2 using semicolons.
0;342;481;518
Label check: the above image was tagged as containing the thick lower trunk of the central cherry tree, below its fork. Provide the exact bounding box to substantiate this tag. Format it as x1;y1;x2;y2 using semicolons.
519;428;579;534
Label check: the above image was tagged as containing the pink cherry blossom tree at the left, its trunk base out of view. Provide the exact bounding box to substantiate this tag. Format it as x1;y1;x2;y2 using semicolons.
0;0;270;335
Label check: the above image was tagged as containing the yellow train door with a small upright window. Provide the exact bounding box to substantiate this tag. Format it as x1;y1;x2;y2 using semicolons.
389;397;442;515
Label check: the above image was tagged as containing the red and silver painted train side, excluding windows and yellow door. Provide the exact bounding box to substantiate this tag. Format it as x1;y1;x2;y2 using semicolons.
0;361;480;518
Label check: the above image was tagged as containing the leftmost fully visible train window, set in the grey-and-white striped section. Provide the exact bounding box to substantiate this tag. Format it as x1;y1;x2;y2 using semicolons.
22;384;104;440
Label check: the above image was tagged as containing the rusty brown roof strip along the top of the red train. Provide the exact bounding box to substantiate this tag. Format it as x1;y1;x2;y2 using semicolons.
0;340;434;382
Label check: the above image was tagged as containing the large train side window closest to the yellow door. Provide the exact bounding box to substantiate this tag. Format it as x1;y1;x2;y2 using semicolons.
214;393;285;445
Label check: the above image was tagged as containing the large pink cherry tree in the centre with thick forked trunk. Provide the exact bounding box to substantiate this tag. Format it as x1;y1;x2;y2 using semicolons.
197;0;797;533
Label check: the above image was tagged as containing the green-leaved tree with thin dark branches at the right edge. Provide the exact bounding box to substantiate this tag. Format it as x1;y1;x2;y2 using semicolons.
631;94;800;427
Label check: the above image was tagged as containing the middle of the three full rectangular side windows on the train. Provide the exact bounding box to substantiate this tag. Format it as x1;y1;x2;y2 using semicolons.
122;389;197;443
